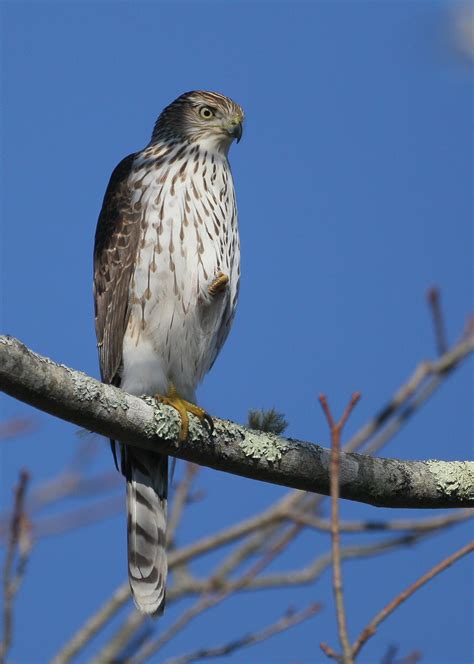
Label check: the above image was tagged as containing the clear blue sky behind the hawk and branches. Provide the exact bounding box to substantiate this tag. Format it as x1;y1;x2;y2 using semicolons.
0;0;473;664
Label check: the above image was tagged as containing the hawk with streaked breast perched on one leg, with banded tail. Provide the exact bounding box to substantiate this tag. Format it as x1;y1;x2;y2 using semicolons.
94;91;244;614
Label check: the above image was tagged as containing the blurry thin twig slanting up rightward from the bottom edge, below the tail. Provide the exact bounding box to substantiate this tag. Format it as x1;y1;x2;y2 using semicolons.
166;604;321;664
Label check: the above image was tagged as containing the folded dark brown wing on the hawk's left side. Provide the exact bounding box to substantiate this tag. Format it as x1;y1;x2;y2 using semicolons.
94;154;140;384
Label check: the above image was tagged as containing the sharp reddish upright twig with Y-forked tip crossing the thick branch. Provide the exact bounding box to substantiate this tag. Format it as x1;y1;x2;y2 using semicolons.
319;392;361;664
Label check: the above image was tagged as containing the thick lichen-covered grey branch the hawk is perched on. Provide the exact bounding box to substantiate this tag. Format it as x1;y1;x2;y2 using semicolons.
0;336;474;508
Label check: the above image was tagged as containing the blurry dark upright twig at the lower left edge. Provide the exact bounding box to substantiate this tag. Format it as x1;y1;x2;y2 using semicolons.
0;470;31;664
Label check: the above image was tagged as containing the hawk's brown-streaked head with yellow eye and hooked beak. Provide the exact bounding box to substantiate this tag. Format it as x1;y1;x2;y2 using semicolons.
152;90;244;154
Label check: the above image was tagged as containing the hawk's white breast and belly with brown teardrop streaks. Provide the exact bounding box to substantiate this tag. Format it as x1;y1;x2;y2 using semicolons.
121;143;240;401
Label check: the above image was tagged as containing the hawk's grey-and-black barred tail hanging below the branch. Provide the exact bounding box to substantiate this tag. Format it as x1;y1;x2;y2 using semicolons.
124;447;168;614
